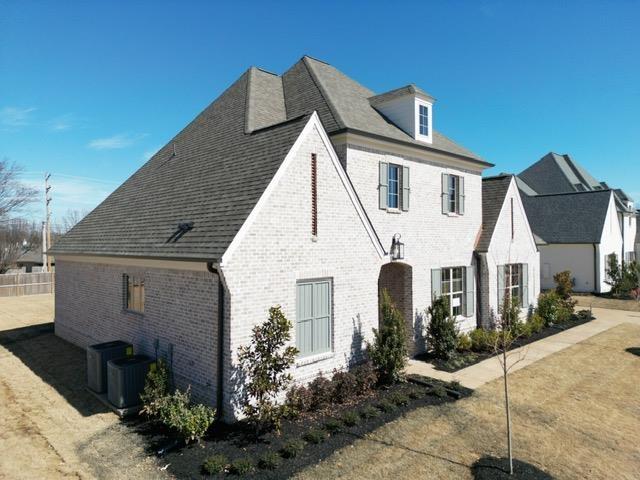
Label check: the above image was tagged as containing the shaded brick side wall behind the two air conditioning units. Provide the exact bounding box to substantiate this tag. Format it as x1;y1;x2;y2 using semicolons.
55;257;218;405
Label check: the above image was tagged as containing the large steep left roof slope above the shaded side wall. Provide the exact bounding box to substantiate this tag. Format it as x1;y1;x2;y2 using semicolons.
52;71;309;260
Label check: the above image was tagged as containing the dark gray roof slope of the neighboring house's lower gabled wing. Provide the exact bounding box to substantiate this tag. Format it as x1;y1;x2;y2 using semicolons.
522;190;612;243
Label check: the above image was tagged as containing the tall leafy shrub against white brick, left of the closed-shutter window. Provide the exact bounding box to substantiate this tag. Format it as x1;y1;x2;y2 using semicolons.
238;306;298;433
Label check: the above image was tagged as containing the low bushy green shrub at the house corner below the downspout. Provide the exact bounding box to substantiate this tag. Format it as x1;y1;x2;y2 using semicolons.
158;389;216;443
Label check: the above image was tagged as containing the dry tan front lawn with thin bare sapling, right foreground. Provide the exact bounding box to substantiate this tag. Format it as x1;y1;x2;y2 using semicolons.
299;324;640;479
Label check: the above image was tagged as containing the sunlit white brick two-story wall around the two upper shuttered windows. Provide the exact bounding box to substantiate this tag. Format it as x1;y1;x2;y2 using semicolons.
337;144;482;336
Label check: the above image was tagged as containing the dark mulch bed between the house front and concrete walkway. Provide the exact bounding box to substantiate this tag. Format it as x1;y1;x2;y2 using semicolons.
415;315;595;373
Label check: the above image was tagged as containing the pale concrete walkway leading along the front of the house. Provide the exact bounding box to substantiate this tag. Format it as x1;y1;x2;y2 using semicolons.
406;308;640;389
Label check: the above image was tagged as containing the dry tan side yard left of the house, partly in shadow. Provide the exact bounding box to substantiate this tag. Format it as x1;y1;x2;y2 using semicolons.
0;295;167;480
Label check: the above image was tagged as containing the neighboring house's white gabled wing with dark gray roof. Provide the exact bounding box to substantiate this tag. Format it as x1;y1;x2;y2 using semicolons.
522;190;622;293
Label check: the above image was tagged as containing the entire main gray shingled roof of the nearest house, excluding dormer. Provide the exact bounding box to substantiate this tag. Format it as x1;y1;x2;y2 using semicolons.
52;57;490;260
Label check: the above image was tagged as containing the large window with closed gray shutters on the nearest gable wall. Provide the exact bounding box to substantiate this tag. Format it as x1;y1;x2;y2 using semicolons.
296;279;332;357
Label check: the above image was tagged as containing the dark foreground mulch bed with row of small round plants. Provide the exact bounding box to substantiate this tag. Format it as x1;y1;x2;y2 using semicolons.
130;376;472;479
